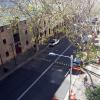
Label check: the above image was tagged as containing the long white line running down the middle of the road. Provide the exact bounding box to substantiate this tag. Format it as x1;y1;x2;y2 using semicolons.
17;44;72;100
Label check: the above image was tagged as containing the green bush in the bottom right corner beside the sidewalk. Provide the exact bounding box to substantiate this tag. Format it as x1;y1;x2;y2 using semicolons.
85;86;100;100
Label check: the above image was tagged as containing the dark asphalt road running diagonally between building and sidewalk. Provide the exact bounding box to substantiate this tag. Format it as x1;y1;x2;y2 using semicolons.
0;38;75;100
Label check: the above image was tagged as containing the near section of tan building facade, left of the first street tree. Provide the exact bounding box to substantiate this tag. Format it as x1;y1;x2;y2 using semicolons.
0;20;32;65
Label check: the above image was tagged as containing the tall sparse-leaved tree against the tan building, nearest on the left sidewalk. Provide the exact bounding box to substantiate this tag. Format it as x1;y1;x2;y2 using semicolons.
11;0;42;51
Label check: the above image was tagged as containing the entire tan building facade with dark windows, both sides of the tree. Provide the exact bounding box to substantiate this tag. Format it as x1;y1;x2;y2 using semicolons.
0;16;61;65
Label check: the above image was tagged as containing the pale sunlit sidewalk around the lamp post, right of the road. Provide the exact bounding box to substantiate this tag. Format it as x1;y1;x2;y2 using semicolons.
54;64;100;100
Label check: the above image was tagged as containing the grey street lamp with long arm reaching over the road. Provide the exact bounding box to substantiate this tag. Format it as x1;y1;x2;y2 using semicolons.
48;52;73;99
